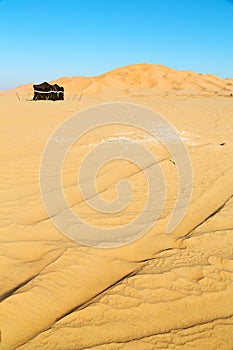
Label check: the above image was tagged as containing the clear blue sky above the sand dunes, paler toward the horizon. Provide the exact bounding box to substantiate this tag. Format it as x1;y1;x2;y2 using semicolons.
0;0;233;89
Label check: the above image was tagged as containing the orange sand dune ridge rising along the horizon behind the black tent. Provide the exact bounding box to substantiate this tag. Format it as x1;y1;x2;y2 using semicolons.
6;64;233;96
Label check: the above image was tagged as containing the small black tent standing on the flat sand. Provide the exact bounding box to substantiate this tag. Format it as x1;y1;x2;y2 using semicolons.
33;82;64;101
